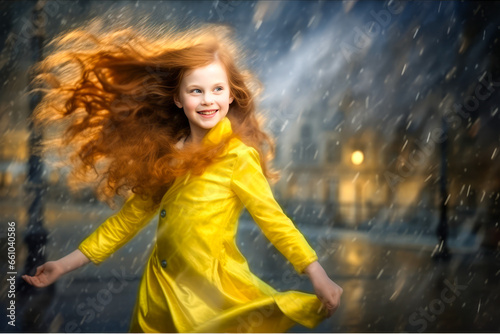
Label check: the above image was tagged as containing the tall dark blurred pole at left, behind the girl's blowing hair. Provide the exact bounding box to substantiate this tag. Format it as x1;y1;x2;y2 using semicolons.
18;1;54;296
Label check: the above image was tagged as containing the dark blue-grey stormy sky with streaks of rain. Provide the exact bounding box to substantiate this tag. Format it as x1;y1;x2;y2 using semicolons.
0;1;500;165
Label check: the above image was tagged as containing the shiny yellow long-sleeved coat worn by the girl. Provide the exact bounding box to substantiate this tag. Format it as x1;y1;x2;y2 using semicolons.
78;117;325;333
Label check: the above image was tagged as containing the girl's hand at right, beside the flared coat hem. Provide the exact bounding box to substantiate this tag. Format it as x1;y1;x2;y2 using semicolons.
305;261;344;318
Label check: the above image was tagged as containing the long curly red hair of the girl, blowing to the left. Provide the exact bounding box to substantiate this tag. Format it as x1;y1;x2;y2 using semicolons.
31;19;278;209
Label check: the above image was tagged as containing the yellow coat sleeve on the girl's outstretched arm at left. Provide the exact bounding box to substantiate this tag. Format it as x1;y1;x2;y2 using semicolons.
78;194;157;265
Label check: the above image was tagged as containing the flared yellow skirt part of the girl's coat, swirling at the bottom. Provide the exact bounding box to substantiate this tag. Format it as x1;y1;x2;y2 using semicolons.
129;247;325;333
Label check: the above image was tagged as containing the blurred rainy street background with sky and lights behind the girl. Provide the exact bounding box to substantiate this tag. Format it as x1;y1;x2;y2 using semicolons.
0;0;500;332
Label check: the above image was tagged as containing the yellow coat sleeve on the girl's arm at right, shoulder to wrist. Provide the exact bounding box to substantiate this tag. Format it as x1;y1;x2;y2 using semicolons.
231;147;318;274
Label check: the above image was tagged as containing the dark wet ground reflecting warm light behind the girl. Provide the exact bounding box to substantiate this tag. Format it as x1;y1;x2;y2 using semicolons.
0;200;500;332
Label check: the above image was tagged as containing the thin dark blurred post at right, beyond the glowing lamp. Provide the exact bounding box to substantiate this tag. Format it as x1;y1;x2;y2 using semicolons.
432;117;450;259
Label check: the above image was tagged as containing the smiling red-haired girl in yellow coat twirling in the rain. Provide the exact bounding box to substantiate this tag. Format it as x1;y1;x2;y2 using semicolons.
23;21;342;332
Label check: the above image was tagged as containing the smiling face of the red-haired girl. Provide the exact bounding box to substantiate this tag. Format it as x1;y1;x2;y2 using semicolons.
174;61;233;141
